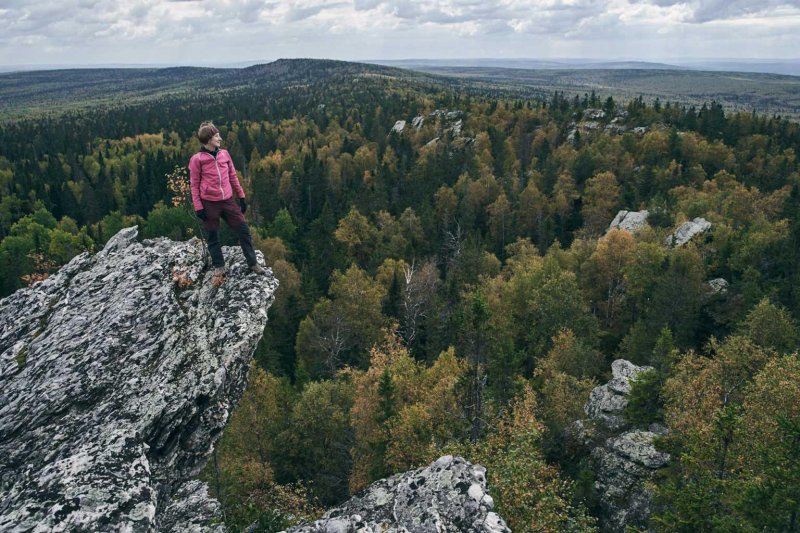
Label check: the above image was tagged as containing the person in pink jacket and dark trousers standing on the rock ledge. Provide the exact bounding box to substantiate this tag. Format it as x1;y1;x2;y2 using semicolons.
189;122;266;285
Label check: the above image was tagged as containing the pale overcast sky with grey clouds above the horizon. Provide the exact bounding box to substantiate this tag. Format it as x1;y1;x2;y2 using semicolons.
0;0;800;65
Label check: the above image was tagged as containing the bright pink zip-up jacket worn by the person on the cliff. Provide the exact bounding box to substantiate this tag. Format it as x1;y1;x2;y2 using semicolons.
189;148;244;211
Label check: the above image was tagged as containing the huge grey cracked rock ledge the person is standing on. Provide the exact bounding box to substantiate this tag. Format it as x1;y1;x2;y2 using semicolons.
0;228;277;532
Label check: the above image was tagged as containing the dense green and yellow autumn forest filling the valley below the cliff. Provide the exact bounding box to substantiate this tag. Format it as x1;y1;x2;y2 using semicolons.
0;61;800;532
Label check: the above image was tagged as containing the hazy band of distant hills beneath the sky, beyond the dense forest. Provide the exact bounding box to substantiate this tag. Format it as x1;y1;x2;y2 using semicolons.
0;59;800;120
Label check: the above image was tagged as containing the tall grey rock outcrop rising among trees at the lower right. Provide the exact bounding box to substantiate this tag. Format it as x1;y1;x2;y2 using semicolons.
570;359;669;533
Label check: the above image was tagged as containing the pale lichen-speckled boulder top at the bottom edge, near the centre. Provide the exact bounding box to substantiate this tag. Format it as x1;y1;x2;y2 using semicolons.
287;455;511;533
